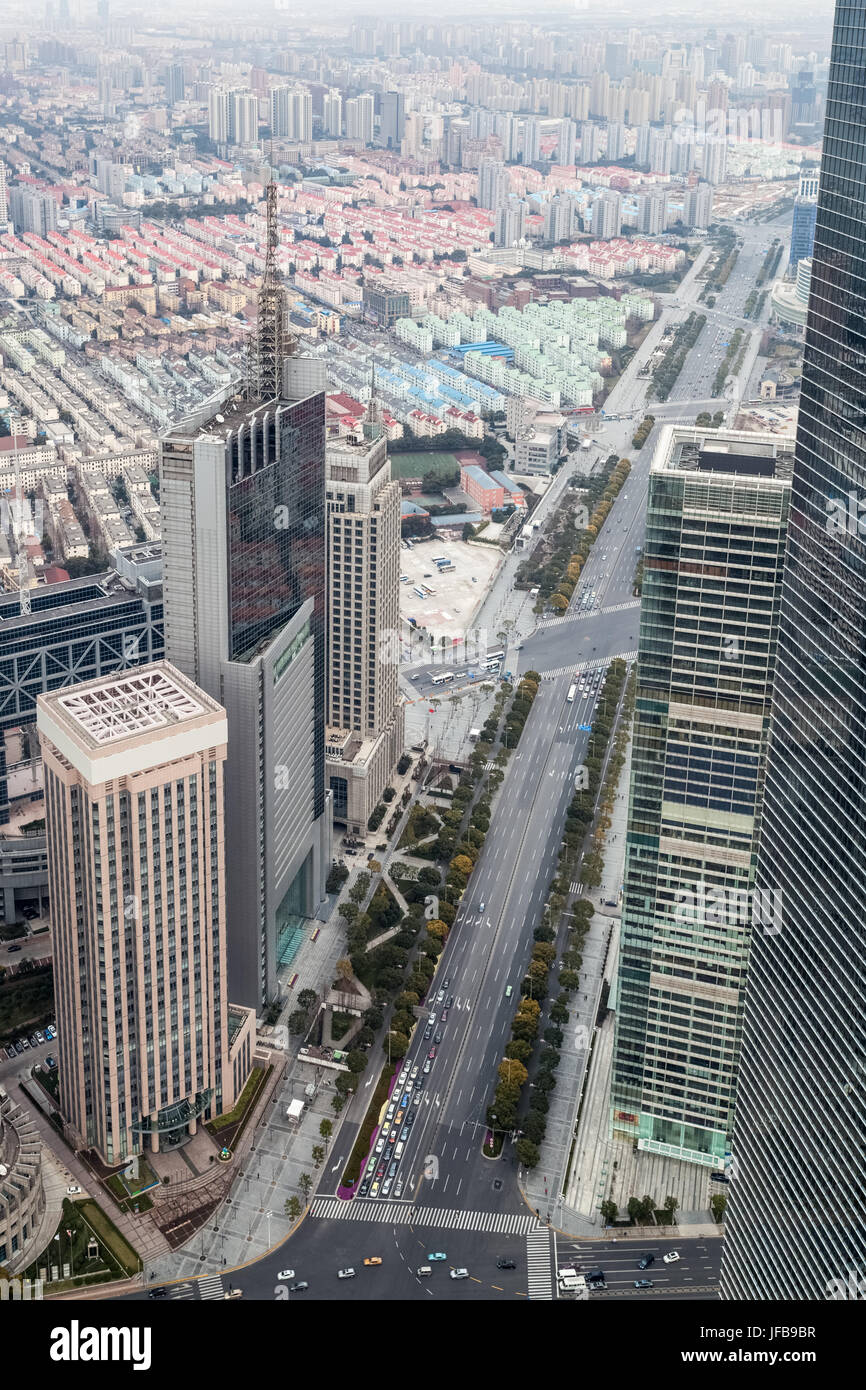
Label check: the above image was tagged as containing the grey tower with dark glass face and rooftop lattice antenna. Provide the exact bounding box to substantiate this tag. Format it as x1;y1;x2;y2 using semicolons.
160;364;329;1008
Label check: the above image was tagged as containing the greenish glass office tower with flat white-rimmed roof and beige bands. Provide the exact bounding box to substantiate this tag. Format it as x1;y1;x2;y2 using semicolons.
612;425;792;1169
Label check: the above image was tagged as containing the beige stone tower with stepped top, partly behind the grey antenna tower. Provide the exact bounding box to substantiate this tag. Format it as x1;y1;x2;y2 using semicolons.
325;399;403;834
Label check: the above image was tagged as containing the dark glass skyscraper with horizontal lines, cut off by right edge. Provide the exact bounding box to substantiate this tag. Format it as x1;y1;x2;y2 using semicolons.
721;0;866;1300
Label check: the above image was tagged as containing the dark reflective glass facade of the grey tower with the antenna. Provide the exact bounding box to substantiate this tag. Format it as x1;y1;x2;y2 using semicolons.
227;395;327;816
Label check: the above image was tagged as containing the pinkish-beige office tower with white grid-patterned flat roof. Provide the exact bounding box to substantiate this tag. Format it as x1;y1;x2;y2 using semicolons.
36;662;254;1165
